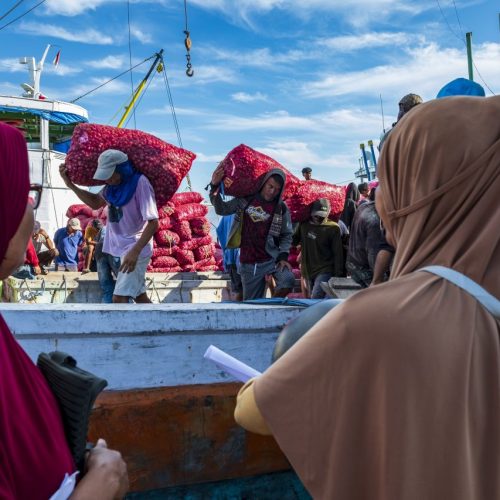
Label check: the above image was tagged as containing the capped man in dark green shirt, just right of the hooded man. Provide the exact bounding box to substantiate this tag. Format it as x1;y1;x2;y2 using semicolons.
292;198;343;299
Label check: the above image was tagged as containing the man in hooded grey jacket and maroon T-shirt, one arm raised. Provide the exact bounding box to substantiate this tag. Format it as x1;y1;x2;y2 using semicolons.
210;165;295;300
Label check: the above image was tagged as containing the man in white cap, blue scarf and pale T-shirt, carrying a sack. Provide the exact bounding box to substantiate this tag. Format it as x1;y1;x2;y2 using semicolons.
59;149;158;303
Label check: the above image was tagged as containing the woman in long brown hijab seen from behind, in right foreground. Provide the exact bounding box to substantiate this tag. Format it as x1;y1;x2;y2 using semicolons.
235;97;500;500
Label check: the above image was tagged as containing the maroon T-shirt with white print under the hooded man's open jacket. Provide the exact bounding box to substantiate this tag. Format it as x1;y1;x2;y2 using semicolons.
240;196;276;264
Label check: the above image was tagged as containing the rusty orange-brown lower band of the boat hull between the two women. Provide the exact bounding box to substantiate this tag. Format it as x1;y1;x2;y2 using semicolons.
89;383;290;491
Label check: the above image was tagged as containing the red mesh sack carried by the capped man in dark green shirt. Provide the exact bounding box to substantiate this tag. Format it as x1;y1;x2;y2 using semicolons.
285;180;345;222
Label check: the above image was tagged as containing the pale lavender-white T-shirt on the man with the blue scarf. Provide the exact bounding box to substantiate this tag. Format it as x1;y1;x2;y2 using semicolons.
103;175;158;258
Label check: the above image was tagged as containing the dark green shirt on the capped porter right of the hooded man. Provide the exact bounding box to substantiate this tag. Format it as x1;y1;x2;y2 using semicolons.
292;220;344;279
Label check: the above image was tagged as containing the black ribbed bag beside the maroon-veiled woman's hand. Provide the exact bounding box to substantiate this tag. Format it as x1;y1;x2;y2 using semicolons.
37;351;108;473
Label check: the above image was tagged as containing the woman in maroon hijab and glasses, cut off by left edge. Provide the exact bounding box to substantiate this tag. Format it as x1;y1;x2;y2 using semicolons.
0;123;128;500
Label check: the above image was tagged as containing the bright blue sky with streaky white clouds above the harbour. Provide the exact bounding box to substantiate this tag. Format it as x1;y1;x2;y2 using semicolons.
0;0;500;190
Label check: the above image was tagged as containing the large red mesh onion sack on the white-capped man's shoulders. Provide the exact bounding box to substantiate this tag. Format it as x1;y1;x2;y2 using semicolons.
65;123;196;206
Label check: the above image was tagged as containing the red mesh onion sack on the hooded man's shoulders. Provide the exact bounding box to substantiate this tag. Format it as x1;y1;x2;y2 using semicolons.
217;144;299;198
